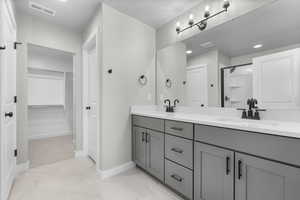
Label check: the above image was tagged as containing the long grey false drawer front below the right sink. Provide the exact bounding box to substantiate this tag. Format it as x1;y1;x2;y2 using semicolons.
195;125;300;167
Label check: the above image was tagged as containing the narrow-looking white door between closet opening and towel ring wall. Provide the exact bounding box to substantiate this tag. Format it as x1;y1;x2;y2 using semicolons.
87;47;98;161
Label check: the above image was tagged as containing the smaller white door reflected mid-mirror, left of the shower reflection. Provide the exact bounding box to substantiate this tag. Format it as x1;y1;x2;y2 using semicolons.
186;65;208;107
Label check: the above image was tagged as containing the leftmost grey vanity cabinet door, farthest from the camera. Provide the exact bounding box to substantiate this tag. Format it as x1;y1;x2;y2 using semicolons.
133;127;147;169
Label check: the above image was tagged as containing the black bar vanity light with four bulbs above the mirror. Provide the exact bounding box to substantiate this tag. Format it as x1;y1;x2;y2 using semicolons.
176;0;230;34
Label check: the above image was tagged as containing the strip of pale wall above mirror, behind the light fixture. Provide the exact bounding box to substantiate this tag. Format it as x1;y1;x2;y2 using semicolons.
156;0;277;49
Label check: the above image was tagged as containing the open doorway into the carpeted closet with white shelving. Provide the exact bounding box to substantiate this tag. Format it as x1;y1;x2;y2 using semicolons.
27;44;75;168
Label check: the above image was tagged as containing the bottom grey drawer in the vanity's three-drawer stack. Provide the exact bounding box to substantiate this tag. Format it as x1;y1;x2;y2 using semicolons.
165;160;193;199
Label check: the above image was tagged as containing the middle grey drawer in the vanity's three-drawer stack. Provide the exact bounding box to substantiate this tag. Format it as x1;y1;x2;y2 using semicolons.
165;135;193;169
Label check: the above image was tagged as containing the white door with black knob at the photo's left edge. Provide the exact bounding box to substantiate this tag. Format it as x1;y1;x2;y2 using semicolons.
0;1;16;200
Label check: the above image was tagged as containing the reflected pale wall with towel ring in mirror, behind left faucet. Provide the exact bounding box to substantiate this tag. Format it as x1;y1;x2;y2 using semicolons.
156;42;187;105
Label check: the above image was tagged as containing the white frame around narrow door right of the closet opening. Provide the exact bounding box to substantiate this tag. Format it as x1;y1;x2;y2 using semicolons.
82;31;100;166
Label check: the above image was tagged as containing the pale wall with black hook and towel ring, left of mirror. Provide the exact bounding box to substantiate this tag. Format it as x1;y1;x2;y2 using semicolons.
100;4;156;170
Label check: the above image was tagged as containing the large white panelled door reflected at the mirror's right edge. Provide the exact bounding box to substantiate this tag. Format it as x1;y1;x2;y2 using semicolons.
253;49;300;108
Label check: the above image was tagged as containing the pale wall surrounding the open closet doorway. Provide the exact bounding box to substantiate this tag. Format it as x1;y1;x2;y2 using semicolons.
17;11;82;163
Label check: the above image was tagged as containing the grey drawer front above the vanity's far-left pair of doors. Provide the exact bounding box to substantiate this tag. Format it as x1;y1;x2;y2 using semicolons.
132;115;164;132
